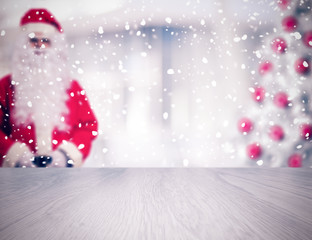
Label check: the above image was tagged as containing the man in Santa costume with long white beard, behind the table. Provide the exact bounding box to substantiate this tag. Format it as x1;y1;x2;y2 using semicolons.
0;9;97;167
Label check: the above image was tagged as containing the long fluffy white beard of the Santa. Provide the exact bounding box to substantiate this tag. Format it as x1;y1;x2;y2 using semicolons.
12;35;70;135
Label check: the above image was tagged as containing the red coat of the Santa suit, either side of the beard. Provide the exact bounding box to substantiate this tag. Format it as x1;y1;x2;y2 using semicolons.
0;75;97;165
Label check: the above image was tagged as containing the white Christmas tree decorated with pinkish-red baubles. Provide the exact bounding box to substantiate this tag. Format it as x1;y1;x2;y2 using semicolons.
237;0;312;167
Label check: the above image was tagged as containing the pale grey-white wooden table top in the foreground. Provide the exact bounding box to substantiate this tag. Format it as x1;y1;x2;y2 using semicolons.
0;168;312;240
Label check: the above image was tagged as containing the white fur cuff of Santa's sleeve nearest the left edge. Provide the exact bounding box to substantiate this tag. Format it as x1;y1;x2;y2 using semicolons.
2;142;31;167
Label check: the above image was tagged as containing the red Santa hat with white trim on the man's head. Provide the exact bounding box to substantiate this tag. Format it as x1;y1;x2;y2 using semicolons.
20;8;63;33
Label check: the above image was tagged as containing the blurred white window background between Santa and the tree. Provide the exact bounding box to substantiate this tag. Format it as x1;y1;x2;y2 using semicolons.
0;0;278;167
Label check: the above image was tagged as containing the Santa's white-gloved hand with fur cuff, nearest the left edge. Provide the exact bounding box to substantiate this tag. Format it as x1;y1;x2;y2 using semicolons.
2;142;35;168
